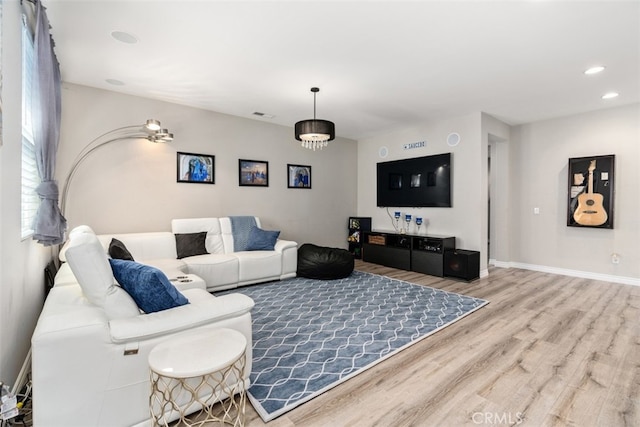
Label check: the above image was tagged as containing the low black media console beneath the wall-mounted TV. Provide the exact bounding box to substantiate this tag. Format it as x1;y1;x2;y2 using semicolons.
362;231;456;277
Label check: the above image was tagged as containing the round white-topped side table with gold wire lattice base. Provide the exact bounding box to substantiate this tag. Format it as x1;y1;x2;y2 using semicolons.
149;329;247;426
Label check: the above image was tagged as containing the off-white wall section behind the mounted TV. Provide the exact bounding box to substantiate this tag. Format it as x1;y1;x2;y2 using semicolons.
358;113;488;270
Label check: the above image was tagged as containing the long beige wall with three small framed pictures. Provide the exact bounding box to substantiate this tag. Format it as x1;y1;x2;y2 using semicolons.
57;84;357;248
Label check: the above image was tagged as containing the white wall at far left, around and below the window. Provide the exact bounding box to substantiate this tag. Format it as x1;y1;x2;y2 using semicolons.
0;1;51;392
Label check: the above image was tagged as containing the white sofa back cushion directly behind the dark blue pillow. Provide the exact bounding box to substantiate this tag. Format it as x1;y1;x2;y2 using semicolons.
66;232;140;319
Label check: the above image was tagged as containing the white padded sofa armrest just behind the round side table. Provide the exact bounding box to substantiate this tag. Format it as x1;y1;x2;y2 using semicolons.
109;289;254;343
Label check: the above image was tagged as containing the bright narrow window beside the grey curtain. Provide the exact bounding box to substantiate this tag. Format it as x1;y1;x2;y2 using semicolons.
21;15;40;239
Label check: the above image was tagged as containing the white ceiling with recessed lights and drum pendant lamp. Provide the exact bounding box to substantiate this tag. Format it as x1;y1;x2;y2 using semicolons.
43;0;640;139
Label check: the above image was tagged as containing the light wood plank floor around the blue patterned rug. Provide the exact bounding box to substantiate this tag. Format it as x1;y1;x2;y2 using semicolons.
231;261;640;427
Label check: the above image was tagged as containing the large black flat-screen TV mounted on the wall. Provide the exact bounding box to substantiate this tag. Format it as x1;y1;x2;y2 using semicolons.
377;153;452;208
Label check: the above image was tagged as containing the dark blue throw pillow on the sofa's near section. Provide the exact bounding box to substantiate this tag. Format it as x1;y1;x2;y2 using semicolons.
109;259;189;313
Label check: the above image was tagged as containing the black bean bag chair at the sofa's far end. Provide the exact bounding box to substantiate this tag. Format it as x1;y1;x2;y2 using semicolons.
297;243;354;280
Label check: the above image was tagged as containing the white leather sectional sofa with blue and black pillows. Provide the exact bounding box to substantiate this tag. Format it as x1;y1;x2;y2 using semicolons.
32;218;297;427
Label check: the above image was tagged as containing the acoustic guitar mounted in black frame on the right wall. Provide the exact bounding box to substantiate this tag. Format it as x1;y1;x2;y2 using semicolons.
567;154;615;228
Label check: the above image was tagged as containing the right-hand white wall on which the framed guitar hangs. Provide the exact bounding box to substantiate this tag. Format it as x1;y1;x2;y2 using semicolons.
510;104;640;284
